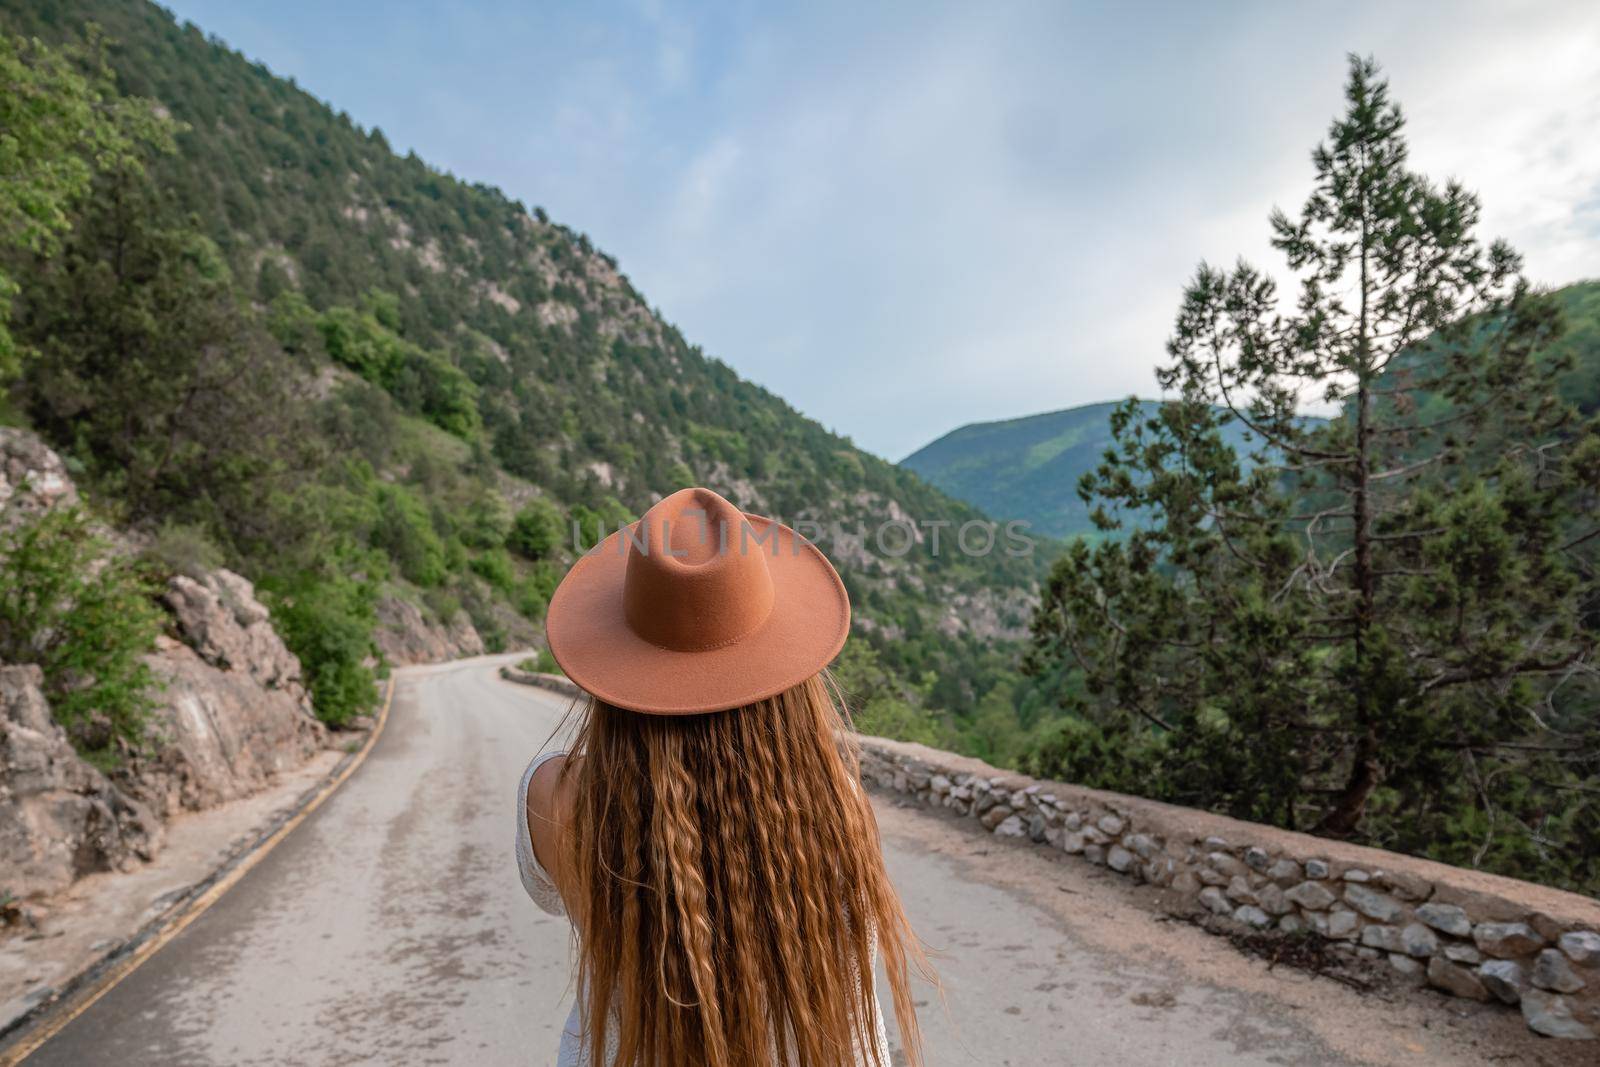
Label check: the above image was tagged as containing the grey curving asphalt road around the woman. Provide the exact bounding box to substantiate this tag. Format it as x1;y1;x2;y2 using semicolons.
18;657;1555;1067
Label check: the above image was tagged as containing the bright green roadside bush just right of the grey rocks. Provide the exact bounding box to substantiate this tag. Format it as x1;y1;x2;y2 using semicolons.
262;571;378;726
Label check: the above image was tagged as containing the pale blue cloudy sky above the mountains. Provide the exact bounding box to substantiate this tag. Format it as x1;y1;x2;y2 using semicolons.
173;0;1600;459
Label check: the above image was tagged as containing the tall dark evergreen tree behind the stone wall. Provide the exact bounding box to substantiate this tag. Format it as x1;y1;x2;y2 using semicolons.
1032;58;1600;881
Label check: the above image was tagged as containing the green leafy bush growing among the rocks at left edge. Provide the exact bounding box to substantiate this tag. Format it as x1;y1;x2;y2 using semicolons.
0;509;165;763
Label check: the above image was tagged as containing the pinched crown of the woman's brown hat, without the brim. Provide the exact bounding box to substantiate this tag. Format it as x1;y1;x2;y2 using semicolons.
622;488;778;651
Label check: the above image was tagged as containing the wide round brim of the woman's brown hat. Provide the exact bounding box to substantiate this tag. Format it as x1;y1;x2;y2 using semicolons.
544;515;850;715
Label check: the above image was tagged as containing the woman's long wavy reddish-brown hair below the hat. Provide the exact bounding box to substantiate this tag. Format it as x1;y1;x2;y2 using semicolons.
562;675;931;1067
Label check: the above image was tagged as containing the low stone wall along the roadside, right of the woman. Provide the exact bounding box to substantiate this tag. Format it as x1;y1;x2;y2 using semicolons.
861;737;1600;1038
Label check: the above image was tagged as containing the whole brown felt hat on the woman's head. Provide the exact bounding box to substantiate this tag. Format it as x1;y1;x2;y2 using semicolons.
546;490;850;715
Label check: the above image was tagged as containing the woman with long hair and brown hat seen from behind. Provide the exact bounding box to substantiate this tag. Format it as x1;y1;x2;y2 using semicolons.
517;490;925;1067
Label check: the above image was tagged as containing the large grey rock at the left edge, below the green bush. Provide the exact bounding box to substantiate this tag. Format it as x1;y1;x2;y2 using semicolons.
0;665;162;897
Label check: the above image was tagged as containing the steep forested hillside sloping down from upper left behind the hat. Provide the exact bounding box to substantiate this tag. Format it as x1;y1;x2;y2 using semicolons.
0;0;1040;742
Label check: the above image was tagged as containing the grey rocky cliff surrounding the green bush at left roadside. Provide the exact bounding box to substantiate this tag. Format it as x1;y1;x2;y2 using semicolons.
0;429;328;897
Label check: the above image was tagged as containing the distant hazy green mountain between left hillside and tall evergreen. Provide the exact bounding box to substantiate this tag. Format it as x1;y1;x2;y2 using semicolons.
901;400;1248;537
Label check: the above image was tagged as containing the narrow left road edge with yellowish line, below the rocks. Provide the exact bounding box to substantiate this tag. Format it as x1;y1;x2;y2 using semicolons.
0;672;397;1067
